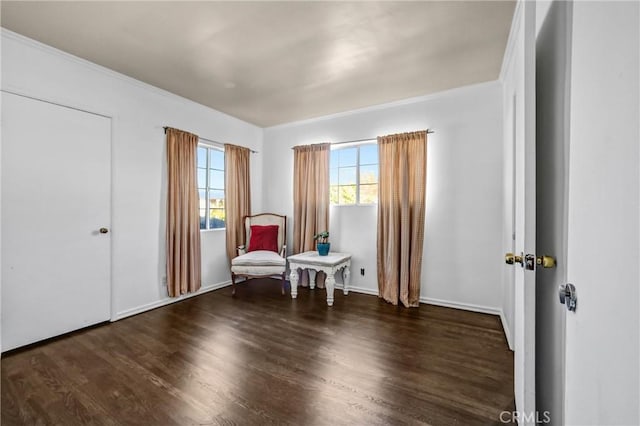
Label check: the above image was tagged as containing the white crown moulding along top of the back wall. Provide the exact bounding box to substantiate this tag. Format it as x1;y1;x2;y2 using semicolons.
263;79;501;131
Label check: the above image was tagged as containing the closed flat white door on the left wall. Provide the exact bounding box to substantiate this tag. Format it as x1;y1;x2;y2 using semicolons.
2;93;111;350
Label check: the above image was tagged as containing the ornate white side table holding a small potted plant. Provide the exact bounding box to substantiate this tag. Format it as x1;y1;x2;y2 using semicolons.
287;251;351;306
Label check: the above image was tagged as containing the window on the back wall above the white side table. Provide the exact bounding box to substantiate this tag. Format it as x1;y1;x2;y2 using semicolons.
329;143;378;205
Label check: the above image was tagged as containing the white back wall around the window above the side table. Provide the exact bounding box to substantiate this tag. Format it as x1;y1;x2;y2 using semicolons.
263;82;503;313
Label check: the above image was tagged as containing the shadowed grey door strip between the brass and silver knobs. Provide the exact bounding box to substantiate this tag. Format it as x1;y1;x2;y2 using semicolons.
536;1;571;425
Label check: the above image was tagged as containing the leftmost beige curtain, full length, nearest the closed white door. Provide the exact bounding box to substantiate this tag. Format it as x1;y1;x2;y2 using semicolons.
166;128;201;297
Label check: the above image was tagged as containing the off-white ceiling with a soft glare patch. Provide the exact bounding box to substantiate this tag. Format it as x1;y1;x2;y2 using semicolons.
0;0;515;127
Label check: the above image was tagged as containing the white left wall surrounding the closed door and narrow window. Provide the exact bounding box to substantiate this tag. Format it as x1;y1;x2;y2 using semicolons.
2;30;263;319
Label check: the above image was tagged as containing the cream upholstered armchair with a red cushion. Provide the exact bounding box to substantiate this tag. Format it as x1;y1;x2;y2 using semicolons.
231;213;287;295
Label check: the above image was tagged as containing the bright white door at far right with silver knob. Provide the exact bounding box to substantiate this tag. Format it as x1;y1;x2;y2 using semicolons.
565;1;640;425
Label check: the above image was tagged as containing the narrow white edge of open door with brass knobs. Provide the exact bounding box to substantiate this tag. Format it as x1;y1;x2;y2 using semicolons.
514;1;536;424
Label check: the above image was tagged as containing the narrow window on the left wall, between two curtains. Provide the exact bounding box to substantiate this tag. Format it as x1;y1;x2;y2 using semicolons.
198;145;225;229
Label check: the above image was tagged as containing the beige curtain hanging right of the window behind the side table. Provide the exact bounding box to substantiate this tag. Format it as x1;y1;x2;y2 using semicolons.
377;131;427;307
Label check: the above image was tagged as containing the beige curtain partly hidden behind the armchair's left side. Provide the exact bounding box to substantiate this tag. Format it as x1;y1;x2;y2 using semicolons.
224;144;251;262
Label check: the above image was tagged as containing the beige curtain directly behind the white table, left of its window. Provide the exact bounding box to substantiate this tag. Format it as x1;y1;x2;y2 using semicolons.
293;143;331;287
